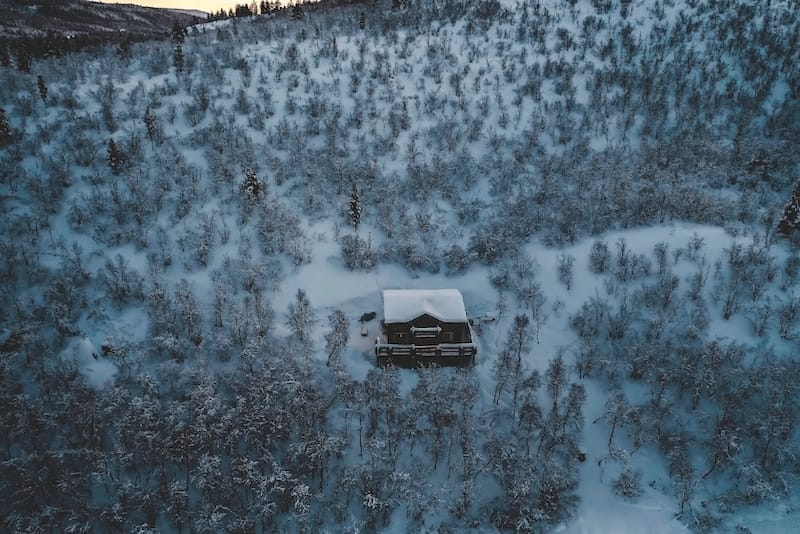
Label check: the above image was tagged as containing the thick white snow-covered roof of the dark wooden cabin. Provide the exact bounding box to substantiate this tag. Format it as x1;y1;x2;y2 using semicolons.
383;289;467;323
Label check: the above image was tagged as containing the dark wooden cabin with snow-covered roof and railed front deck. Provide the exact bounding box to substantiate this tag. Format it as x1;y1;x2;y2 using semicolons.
375;289;478;367
